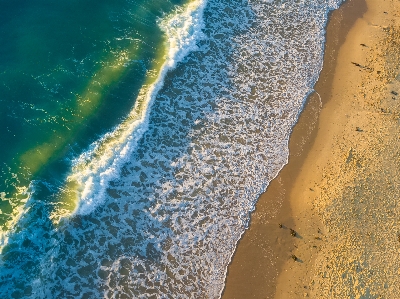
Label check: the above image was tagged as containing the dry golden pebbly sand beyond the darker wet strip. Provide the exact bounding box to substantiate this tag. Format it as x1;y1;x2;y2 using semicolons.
276;0;400;298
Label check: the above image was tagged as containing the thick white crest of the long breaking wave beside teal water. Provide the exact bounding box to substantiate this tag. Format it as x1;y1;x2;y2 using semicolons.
67;0;206;215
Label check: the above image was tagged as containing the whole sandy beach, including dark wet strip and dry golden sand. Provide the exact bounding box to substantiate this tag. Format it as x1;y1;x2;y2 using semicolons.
223;0;400;298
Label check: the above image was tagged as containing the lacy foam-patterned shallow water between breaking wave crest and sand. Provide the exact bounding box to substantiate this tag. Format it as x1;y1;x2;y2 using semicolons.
0;0;338;298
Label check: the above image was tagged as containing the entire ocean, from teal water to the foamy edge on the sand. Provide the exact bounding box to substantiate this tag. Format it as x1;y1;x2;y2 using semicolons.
0;0;341;298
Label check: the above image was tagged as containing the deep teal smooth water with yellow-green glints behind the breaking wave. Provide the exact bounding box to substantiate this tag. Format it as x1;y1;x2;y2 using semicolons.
0;0;183;231
